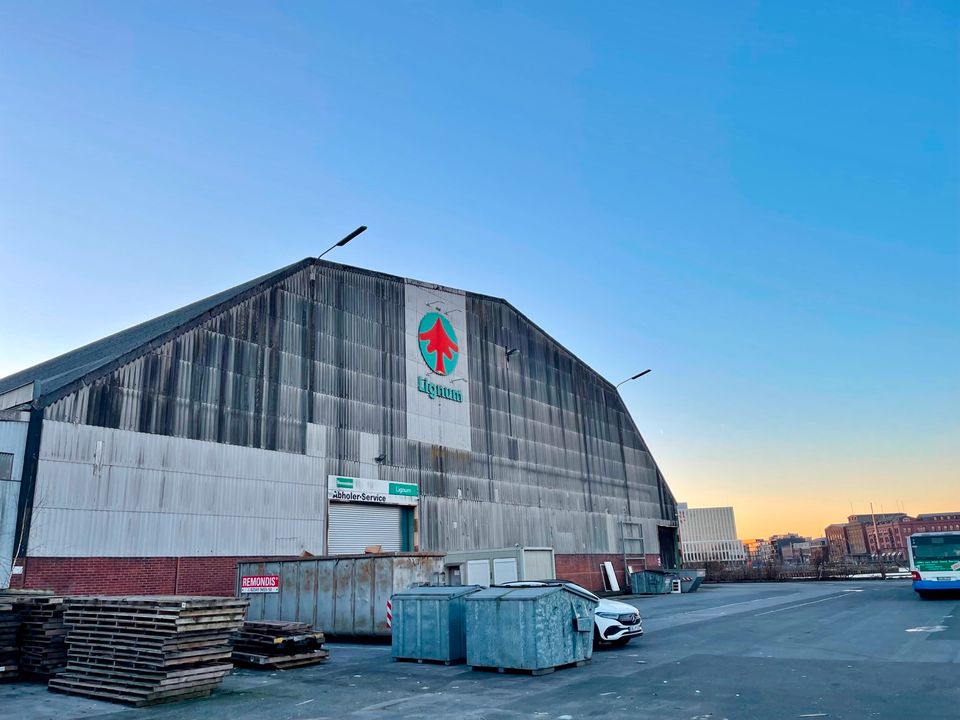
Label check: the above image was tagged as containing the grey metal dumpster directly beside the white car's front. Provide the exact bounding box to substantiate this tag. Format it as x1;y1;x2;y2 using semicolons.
466;584;598;675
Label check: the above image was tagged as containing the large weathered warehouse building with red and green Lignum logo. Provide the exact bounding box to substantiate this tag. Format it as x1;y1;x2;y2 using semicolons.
0;258;677;594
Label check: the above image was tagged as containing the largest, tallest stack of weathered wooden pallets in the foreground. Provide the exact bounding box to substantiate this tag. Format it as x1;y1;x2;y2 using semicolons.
50;596;247;706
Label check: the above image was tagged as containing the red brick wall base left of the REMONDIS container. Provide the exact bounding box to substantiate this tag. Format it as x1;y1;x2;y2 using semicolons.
10;557;276;596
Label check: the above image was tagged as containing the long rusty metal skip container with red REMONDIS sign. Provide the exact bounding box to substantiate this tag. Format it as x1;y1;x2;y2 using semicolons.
237;553;443;637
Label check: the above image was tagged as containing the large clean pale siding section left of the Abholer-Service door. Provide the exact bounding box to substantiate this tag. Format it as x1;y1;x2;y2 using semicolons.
30;421;327;557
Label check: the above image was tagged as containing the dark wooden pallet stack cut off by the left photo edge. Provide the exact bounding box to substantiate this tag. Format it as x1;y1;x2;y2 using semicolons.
0;589;67;681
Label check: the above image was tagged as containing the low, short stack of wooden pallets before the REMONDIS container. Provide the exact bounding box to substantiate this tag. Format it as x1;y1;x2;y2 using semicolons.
233;620;330;670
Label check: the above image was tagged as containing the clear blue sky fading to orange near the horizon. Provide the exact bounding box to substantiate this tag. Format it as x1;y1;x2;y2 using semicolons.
0;0;960;537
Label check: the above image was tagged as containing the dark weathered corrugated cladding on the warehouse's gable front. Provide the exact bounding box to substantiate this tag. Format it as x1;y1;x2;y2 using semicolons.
39;263;674;554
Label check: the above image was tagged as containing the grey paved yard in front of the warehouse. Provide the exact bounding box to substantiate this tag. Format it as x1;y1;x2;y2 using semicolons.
0;580;960;720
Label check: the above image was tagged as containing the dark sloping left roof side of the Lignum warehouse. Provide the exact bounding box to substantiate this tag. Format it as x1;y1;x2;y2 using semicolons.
0;258;314;400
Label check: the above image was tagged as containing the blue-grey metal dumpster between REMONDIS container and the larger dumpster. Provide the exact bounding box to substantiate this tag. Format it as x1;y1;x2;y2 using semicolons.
391;585;480;664
